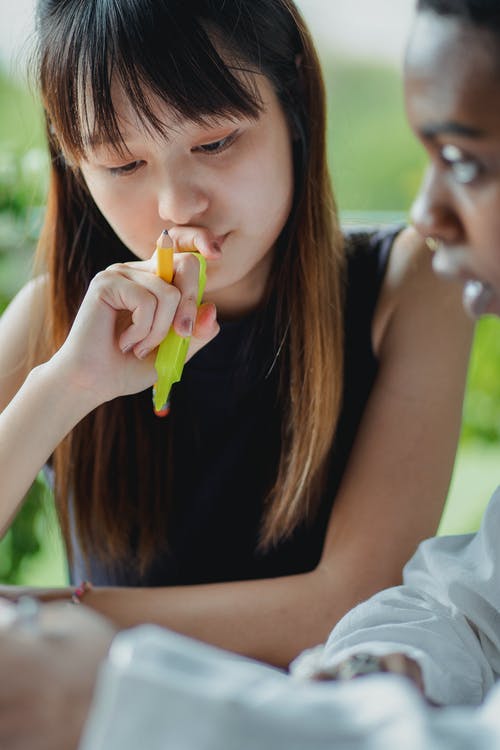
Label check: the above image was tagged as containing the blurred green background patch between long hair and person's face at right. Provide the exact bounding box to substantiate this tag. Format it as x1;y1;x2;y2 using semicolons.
325;60;425;214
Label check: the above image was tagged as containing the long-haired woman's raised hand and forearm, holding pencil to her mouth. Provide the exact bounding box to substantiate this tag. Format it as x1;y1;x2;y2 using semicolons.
0;235;220;528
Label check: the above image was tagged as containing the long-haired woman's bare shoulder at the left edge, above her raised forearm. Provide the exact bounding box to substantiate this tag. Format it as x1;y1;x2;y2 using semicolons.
0;275;48;410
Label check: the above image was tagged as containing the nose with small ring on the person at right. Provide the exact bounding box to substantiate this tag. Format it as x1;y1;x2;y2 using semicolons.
411;166;463;244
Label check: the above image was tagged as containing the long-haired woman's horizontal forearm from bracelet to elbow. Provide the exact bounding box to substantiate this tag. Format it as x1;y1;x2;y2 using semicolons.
83;568;389;667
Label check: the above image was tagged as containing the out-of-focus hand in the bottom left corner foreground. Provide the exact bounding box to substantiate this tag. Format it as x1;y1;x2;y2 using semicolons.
0;600;115;750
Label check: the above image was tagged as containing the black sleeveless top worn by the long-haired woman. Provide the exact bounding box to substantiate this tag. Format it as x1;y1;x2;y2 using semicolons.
70;228;399;586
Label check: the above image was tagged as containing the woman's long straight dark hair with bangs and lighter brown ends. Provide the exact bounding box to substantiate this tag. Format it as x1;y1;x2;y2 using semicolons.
31;0;344;571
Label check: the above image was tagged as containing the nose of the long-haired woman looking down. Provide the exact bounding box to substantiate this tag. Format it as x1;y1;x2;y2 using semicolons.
158;170;209;226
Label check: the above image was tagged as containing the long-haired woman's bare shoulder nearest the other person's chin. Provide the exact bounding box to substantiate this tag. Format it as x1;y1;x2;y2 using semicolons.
373;227;473;353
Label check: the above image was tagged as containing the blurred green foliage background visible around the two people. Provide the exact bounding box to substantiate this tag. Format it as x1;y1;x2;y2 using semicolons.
0;60;500;585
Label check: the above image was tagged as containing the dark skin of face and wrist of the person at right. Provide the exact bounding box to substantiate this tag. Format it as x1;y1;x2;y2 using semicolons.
350;12;500;694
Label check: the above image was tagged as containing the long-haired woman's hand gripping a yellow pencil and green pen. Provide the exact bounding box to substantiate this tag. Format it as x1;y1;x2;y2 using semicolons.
51;238;220;406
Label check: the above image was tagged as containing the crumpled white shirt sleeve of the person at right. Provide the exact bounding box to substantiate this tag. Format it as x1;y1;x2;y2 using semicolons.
310;488;500;708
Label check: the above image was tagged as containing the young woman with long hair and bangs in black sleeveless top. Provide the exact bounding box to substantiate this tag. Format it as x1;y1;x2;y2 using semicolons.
0;0;471;665
